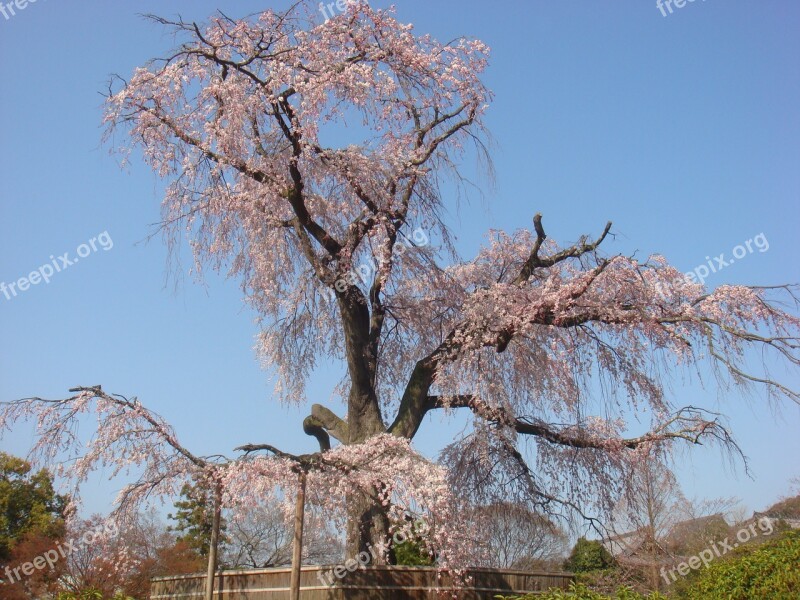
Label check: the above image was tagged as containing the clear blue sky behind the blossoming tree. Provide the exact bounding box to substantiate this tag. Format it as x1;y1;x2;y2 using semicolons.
0;0;800;510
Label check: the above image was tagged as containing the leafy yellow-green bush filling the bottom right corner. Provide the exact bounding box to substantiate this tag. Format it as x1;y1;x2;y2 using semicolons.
680;531;800;600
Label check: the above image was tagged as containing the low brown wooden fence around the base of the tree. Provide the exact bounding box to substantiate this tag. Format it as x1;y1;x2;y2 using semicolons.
150;567;572;600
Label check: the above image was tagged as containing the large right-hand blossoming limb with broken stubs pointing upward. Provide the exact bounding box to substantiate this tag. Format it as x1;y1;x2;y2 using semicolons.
390;215;800;436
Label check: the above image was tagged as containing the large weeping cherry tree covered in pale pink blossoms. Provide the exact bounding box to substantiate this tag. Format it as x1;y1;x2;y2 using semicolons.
6;2;800;572
